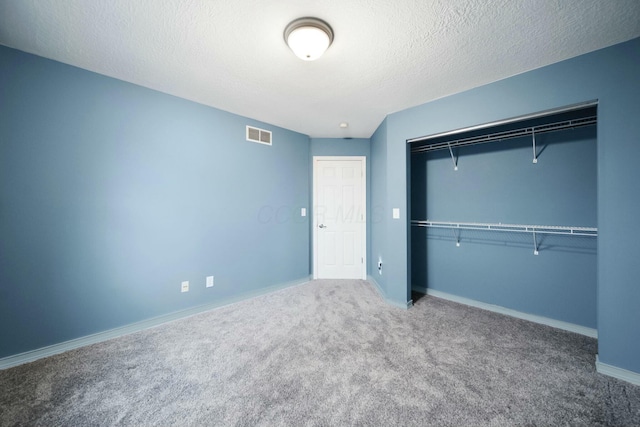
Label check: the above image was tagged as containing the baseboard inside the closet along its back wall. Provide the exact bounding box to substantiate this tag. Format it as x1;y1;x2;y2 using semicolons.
413;286;598;338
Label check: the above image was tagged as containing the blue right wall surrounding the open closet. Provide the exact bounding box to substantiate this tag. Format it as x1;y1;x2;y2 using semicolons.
372;39;640;372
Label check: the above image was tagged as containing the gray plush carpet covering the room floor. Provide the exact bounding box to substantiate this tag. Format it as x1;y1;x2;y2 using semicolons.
0;280;640;426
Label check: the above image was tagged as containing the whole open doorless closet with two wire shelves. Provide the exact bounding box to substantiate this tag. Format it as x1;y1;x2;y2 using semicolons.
407;101;598;336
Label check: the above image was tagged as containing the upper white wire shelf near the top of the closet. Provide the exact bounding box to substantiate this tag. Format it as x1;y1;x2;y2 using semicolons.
411;116;597;153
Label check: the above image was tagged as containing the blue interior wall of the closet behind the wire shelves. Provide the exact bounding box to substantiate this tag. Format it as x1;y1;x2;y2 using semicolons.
411;126;597;328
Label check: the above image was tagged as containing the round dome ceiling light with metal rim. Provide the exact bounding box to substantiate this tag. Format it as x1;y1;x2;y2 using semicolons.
284;18;333;61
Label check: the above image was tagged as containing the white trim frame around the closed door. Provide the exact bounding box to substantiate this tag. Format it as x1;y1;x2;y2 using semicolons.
311;156;369;280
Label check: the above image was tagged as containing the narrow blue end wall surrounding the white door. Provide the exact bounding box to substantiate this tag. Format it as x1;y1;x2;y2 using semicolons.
309;138;372;278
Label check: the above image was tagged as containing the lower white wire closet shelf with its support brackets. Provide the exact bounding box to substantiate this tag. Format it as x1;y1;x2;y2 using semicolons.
411;220;598;255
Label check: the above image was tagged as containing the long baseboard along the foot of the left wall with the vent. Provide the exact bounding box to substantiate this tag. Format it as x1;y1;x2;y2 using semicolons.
0;276;311;370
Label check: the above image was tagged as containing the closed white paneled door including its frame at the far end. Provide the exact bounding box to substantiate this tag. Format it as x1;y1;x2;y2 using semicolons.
313;157;367;279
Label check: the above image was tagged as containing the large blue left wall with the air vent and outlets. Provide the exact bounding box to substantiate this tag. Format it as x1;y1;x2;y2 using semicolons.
0;47;310;358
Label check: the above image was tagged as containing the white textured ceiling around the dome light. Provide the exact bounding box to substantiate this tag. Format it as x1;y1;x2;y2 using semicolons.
0;0;640;137
